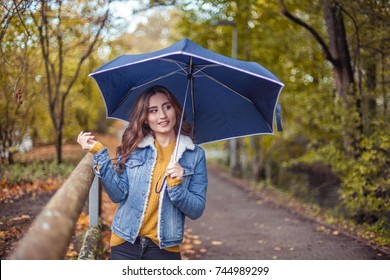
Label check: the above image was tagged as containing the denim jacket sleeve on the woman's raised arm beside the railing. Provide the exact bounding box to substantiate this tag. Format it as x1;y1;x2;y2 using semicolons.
93;148;129;203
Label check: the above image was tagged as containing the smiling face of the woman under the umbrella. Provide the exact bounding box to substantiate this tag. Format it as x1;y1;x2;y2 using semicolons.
147;92;176;137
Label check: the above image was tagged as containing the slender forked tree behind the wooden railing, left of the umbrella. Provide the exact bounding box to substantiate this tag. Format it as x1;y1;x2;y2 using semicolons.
31;0;110;163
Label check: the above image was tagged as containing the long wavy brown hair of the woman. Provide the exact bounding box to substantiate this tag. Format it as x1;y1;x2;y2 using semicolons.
116;85;191;172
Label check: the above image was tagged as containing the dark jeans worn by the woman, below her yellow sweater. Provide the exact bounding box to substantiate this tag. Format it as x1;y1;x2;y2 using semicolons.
110;236;181;260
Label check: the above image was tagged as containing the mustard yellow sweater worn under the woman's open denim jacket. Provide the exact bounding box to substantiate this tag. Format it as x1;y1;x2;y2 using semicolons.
90;140;182;252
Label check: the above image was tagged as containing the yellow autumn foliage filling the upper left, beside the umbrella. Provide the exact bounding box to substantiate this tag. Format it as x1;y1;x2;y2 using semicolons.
0;1;111;156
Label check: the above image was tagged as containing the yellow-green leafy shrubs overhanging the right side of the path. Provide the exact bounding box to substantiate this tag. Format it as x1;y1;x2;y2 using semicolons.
284;96;390;224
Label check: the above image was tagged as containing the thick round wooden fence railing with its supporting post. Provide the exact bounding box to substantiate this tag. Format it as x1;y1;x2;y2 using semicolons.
10;154;100;260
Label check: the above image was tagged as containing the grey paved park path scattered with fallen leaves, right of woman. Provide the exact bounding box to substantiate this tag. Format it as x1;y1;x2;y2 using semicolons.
186;165;390;260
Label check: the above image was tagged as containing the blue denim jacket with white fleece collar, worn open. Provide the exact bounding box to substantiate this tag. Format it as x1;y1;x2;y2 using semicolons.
94;135;207;248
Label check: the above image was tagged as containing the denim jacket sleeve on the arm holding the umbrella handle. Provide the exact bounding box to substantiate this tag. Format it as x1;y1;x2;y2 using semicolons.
167;147;208;220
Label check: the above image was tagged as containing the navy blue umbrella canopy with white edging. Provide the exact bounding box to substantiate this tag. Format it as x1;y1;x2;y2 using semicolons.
90;39;283;144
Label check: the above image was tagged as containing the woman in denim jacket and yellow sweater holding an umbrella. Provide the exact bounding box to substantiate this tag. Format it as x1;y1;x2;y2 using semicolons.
77;86;207;259
